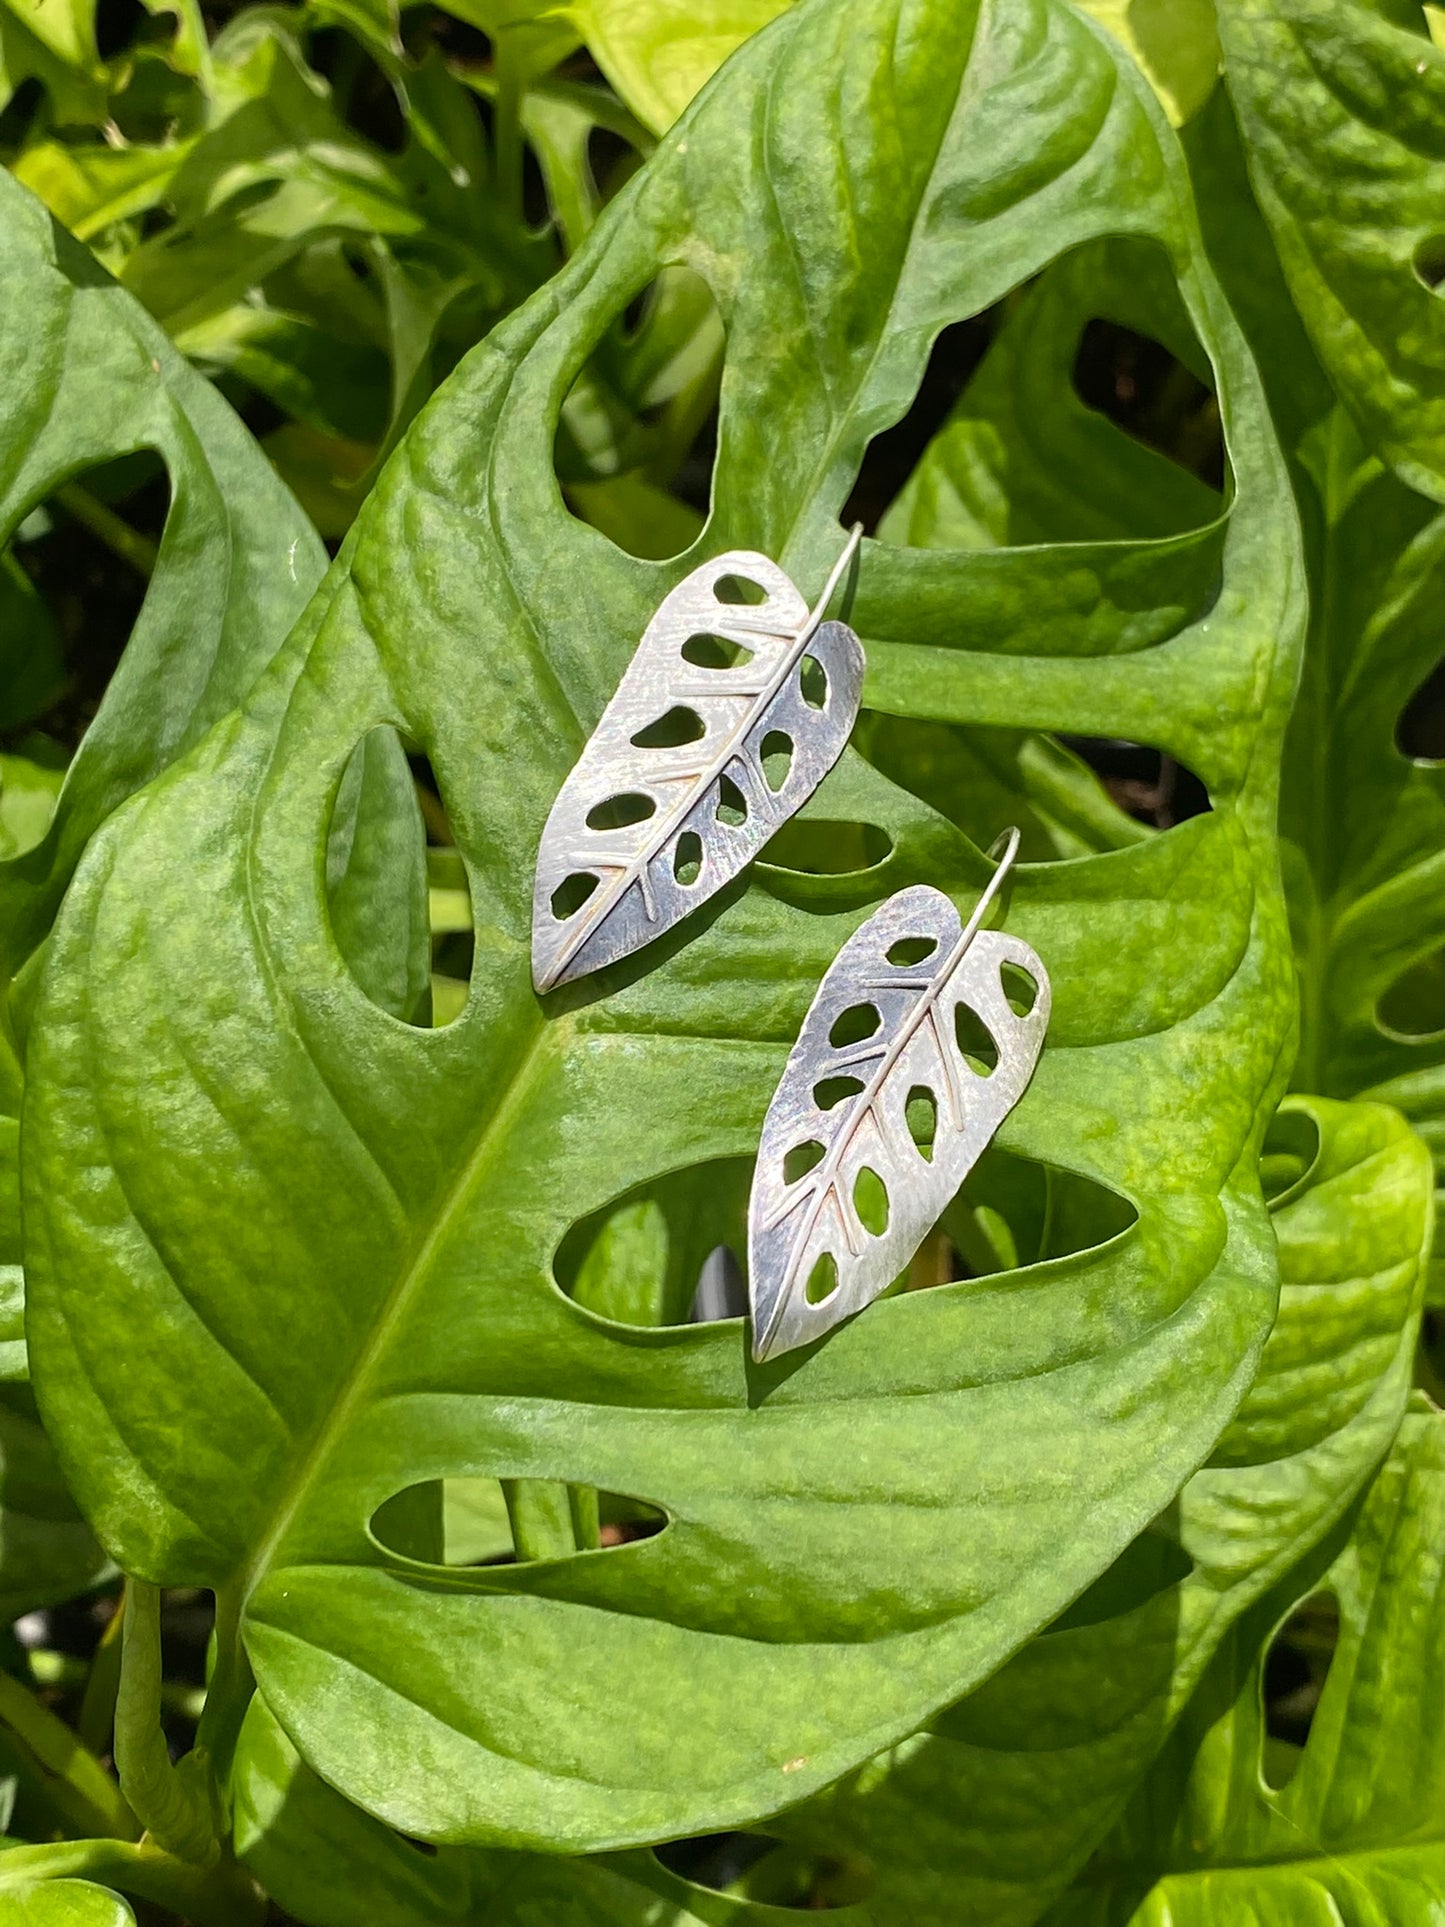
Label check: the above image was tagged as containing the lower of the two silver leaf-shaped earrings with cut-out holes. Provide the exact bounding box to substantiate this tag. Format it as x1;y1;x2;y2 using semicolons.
748;831;1050;1359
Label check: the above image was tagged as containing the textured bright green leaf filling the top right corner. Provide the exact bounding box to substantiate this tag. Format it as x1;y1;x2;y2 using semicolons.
1218;0;1445;501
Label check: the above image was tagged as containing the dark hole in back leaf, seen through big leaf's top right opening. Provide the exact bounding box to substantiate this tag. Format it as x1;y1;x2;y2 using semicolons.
1073;316;1225;491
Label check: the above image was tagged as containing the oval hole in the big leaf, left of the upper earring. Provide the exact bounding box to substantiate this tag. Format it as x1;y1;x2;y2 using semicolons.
326;725;446;1027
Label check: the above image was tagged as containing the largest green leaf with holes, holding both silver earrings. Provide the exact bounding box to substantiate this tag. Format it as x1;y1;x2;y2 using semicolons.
25;0;1302;1848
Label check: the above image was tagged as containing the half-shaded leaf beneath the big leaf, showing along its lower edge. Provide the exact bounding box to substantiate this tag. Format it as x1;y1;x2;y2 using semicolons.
237;1098;1430;1927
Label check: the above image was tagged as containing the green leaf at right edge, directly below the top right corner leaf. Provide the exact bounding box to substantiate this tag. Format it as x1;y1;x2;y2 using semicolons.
1283;447;1445;1294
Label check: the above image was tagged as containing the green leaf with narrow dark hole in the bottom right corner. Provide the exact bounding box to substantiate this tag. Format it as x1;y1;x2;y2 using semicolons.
1048;1403;1445;1927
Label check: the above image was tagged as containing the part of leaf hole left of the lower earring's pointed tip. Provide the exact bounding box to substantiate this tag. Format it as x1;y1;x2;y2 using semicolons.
553;1158;753;1326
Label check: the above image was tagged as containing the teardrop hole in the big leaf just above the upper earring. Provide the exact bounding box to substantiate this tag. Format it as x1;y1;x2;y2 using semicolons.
553;266;724;561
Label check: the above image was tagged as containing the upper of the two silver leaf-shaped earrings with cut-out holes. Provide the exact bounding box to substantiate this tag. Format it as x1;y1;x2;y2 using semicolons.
532;528;863;990
